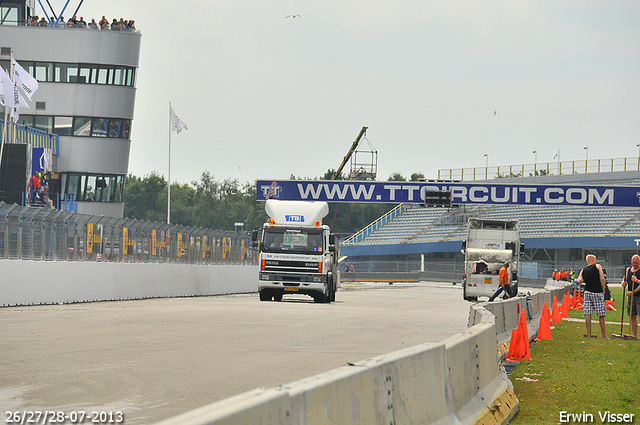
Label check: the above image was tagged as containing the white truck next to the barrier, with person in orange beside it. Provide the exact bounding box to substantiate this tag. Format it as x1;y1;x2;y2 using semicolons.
462;218;524;301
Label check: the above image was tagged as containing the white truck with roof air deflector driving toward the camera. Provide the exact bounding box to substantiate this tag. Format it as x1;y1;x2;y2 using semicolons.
252;199;340;303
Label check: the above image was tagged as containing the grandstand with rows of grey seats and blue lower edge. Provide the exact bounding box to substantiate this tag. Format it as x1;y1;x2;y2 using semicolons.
341;166;640;279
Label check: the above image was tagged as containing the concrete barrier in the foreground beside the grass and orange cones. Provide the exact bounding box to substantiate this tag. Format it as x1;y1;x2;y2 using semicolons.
151;280;568;425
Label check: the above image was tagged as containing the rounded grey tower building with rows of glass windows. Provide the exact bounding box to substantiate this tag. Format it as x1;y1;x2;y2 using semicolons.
0;0;141;217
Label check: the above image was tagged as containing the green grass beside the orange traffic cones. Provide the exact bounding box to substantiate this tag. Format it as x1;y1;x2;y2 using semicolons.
511;288;640;425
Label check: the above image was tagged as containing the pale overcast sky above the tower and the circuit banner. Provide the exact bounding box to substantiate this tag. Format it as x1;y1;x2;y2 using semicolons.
51;0;640;184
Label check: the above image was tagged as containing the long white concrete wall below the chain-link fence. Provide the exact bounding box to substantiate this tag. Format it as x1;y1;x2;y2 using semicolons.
0;260;258;306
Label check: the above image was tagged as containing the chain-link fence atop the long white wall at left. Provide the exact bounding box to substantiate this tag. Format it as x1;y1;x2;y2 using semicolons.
0;202;257;264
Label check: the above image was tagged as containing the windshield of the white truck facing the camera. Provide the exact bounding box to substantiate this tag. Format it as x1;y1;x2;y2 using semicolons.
262;228;323;254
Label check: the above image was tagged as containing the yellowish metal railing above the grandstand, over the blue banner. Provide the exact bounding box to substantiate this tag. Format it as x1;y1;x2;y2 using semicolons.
438;156;640;181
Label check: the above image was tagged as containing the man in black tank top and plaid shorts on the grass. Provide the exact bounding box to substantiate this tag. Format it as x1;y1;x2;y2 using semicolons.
578;254;609;339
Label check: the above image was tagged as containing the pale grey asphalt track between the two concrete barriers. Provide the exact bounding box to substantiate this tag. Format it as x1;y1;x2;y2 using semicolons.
0;283;469;424
